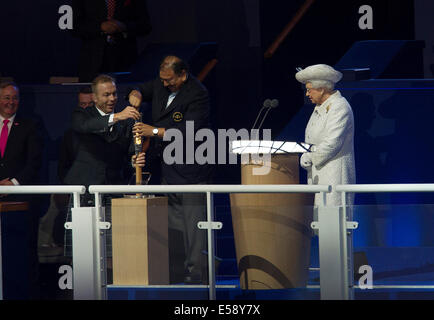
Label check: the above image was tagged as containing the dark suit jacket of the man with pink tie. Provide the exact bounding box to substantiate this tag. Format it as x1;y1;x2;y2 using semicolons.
0;115;43;185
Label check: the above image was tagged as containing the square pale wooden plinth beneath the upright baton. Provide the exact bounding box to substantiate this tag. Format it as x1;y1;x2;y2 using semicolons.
112;197;169;285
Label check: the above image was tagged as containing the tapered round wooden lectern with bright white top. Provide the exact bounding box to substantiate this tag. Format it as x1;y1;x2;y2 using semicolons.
230;141;313;289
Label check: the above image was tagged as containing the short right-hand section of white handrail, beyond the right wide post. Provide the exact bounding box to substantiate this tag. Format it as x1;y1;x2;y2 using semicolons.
332;183;434;193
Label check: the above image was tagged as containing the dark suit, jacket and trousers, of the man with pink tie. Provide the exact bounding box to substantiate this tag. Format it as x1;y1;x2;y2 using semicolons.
0;115;43;300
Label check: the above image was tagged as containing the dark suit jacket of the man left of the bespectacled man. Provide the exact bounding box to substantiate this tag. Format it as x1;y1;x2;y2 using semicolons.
65;106;132;187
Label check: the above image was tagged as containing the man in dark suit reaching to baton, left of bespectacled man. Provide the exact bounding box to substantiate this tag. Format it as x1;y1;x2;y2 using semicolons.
64;75;145;257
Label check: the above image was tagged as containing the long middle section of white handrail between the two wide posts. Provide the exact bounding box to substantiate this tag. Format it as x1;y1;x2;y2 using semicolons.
89;184;331;194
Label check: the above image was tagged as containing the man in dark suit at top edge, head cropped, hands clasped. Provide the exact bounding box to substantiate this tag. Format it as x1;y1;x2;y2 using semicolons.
72;0;151;82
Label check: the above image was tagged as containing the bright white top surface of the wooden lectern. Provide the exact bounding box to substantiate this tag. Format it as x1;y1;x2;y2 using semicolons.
231;140;312;154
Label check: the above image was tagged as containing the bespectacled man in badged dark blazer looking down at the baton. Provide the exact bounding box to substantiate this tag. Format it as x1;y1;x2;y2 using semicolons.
129;56;211;284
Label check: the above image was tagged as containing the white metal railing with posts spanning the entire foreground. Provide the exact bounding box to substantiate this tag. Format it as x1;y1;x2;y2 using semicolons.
0;184;434;300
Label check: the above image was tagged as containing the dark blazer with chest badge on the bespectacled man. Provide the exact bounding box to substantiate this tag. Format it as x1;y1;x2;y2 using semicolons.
137;75;212;184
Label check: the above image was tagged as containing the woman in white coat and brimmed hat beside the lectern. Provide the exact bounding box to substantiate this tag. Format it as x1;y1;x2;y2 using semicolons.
295;64;356;206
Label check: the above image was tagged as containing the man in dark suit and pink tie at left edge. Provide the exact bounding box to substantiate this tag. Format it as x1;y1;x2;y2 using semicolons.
0;82;43;299
